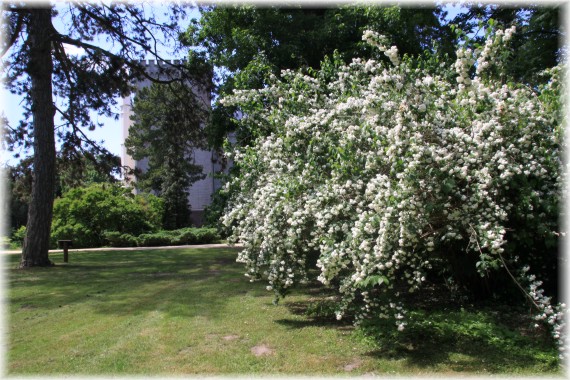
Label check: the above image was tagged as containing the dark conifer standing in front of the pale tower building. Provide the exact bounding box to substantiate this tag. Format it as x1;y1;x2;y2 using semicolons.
125;80;210;229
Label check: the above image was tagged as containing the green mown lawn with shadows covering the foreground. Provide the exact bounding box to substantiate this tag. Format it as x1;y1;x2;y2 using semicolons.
3;249;560;376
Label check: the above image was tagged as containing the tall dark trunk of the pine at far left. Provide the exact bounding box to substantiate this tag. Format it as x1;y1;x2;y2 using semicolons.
20;7;55;268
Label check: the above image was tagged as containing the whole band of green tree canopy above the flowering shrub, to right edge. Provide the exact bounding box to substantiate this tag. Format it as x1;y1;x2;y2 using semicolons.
183;4;562;146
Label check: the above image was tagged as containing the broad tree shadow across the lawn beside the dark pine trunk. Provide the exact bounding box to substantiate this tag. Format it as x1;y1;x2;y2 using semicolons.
8;249;262;317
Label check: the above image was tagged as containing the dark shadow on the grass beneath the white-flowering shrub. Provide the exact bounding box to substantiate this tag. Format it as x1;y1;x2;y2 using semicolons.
276;288;559;374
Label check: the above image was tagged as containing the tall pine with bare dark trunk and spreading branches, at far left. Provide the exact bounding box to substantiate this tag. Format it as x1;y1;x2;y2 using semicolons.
1;2;200;268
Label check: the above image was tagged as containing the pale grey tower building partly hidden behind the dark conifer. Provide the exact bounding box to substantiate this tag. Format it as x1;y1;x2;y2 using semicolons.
121;60;224;226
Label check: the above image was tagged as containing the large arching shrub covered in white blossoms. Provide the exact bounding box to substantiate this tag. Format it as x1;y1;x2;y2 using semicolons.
222;30;563;350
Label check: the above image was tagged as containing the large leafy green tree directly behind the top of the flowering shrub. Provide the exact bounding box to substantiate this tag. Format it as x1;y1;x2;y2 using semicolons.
184;5;453;145
